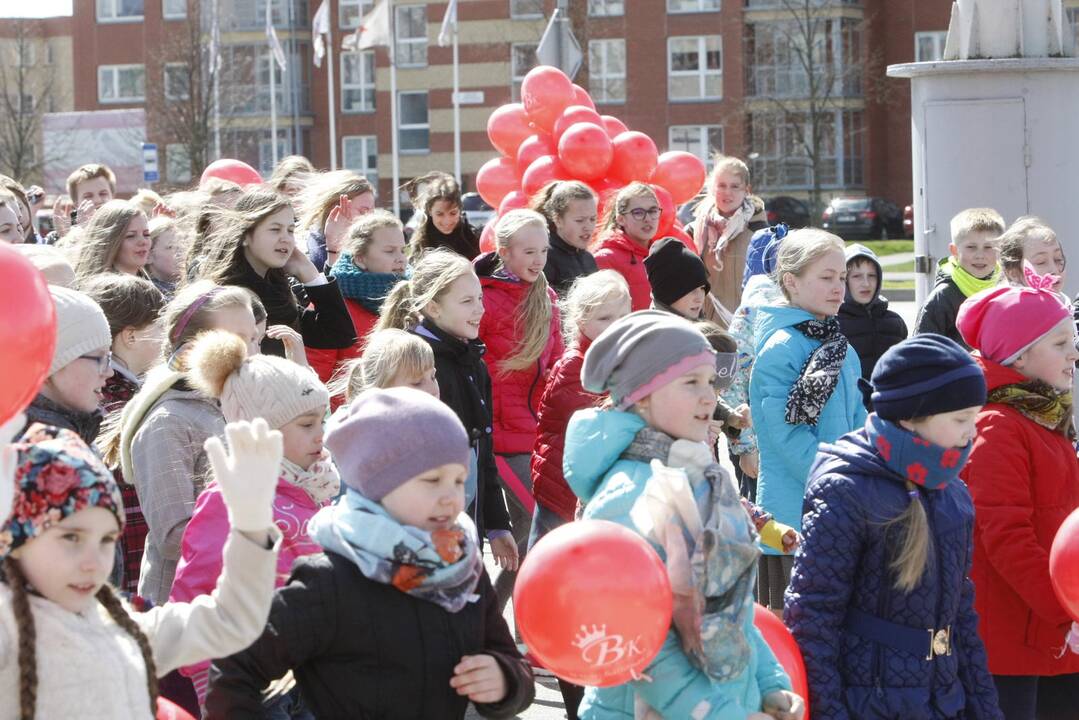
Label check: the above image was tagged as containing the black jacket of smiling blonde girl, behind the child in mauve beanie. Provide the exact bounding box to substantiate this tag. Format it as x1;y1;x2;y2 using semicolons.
412;321;509;538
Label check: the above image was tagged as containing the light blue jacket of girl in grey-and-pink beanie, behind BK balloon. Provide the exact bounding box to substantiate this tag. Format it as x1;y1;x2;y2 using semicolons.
562;408;791;720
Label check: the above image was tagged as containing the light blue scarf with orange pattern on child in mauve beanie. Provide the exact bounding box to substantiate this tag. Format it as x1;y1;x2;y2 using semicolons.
308;488;483;612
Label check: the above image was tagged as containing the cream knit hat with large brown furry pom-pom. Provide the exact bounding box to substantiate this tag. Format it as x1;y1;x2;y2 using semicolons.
187;330;330;430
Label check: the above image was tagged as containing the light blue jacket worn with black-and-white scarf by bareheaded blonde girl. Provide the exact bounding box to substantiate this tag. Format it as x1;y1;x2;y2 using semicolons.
749;305;865;555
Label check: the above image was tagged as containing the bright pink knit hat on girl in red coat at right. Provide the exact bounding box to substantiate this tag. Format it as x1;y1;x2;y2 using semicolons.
955;281;1071;365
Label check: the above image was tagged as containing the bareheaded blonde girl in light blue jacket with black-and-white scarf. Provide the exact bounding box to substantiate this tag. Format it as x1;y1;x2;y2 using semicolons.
749;229;865;610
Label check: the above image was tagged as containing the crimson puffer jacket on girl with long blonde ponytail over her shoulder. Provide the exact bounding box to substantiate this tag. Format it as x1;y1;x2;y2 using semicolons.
475;253;562;454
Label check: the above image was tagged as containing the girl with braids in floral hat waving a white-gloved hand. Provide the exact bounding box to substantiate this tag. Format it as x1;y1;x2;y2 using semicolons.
0;421;281;720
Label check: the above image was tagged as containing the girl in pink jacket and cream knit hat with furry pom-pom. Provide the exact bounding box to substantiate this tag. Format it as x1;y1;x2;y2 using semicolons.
168;330;340;706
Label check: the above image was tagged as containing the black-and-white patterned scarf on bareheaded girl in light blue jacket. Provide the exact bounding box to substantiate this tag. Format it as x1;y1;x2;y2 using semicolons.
786;317;847;425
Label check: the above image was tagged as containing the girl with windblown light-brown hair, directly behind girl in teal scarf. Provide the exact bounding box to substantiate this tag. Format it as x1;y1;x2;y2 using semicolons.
297;171;374;272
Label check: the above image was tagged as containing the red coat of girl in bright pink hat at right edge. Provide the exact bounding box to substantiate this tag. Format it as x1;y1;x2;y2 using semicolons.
960;357;1079;676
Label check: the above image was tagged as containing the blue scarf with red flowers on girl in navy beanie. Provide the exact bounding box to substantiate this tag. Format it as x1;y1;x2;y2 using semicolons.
865;412;974;490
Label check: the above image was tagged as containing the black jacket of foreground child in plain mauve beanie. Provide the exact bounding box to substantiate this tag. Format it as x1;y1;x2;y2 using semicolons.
205;553;535;720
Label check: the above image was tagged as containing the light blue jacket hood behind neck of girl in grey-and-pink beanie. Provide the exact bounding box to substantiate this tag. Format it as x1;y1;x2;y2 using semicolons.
562;408;646;503
